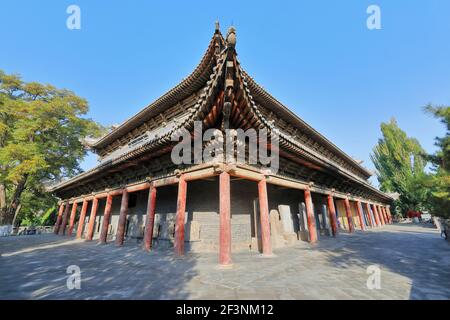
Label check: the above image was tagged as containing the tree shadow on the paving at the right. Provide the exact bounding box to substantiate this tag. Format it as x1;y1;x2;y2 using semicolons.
315;224;450;300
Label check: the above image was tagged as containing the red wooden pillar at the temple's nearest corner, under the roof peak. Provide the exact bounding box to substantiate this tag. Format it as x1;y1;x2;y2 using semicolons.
219;172;231;266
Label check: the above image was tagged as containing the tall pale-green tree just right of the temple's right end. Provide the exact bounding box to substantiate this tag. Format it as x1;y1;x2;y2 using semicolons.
371;119;430;213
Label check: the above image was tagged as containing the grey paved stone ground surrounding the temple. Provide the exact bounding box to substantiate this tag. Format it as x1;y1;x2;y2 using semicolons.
0;225;450;300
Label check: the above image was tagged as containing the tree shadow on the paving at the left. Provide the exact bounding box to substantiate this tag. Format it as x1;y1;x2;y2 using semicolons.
0;235;196;299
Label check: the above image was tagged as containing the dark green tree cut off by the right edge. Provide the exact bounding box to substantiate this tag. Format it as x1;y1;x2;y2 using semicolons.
425;105;450;218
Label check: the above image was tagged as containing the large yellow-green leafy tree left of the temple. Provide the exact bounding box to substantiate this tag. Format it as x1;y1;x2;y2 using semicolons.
0;70;103;224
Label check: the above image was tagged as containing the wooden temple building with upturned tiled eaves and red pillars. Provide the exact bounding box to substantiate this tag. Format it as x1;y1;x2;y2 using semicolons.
51;24;392;265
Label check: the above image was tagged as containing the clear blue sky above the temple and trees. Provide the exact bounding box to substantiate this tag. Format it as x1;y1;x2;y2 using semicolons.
0;0;450;185
